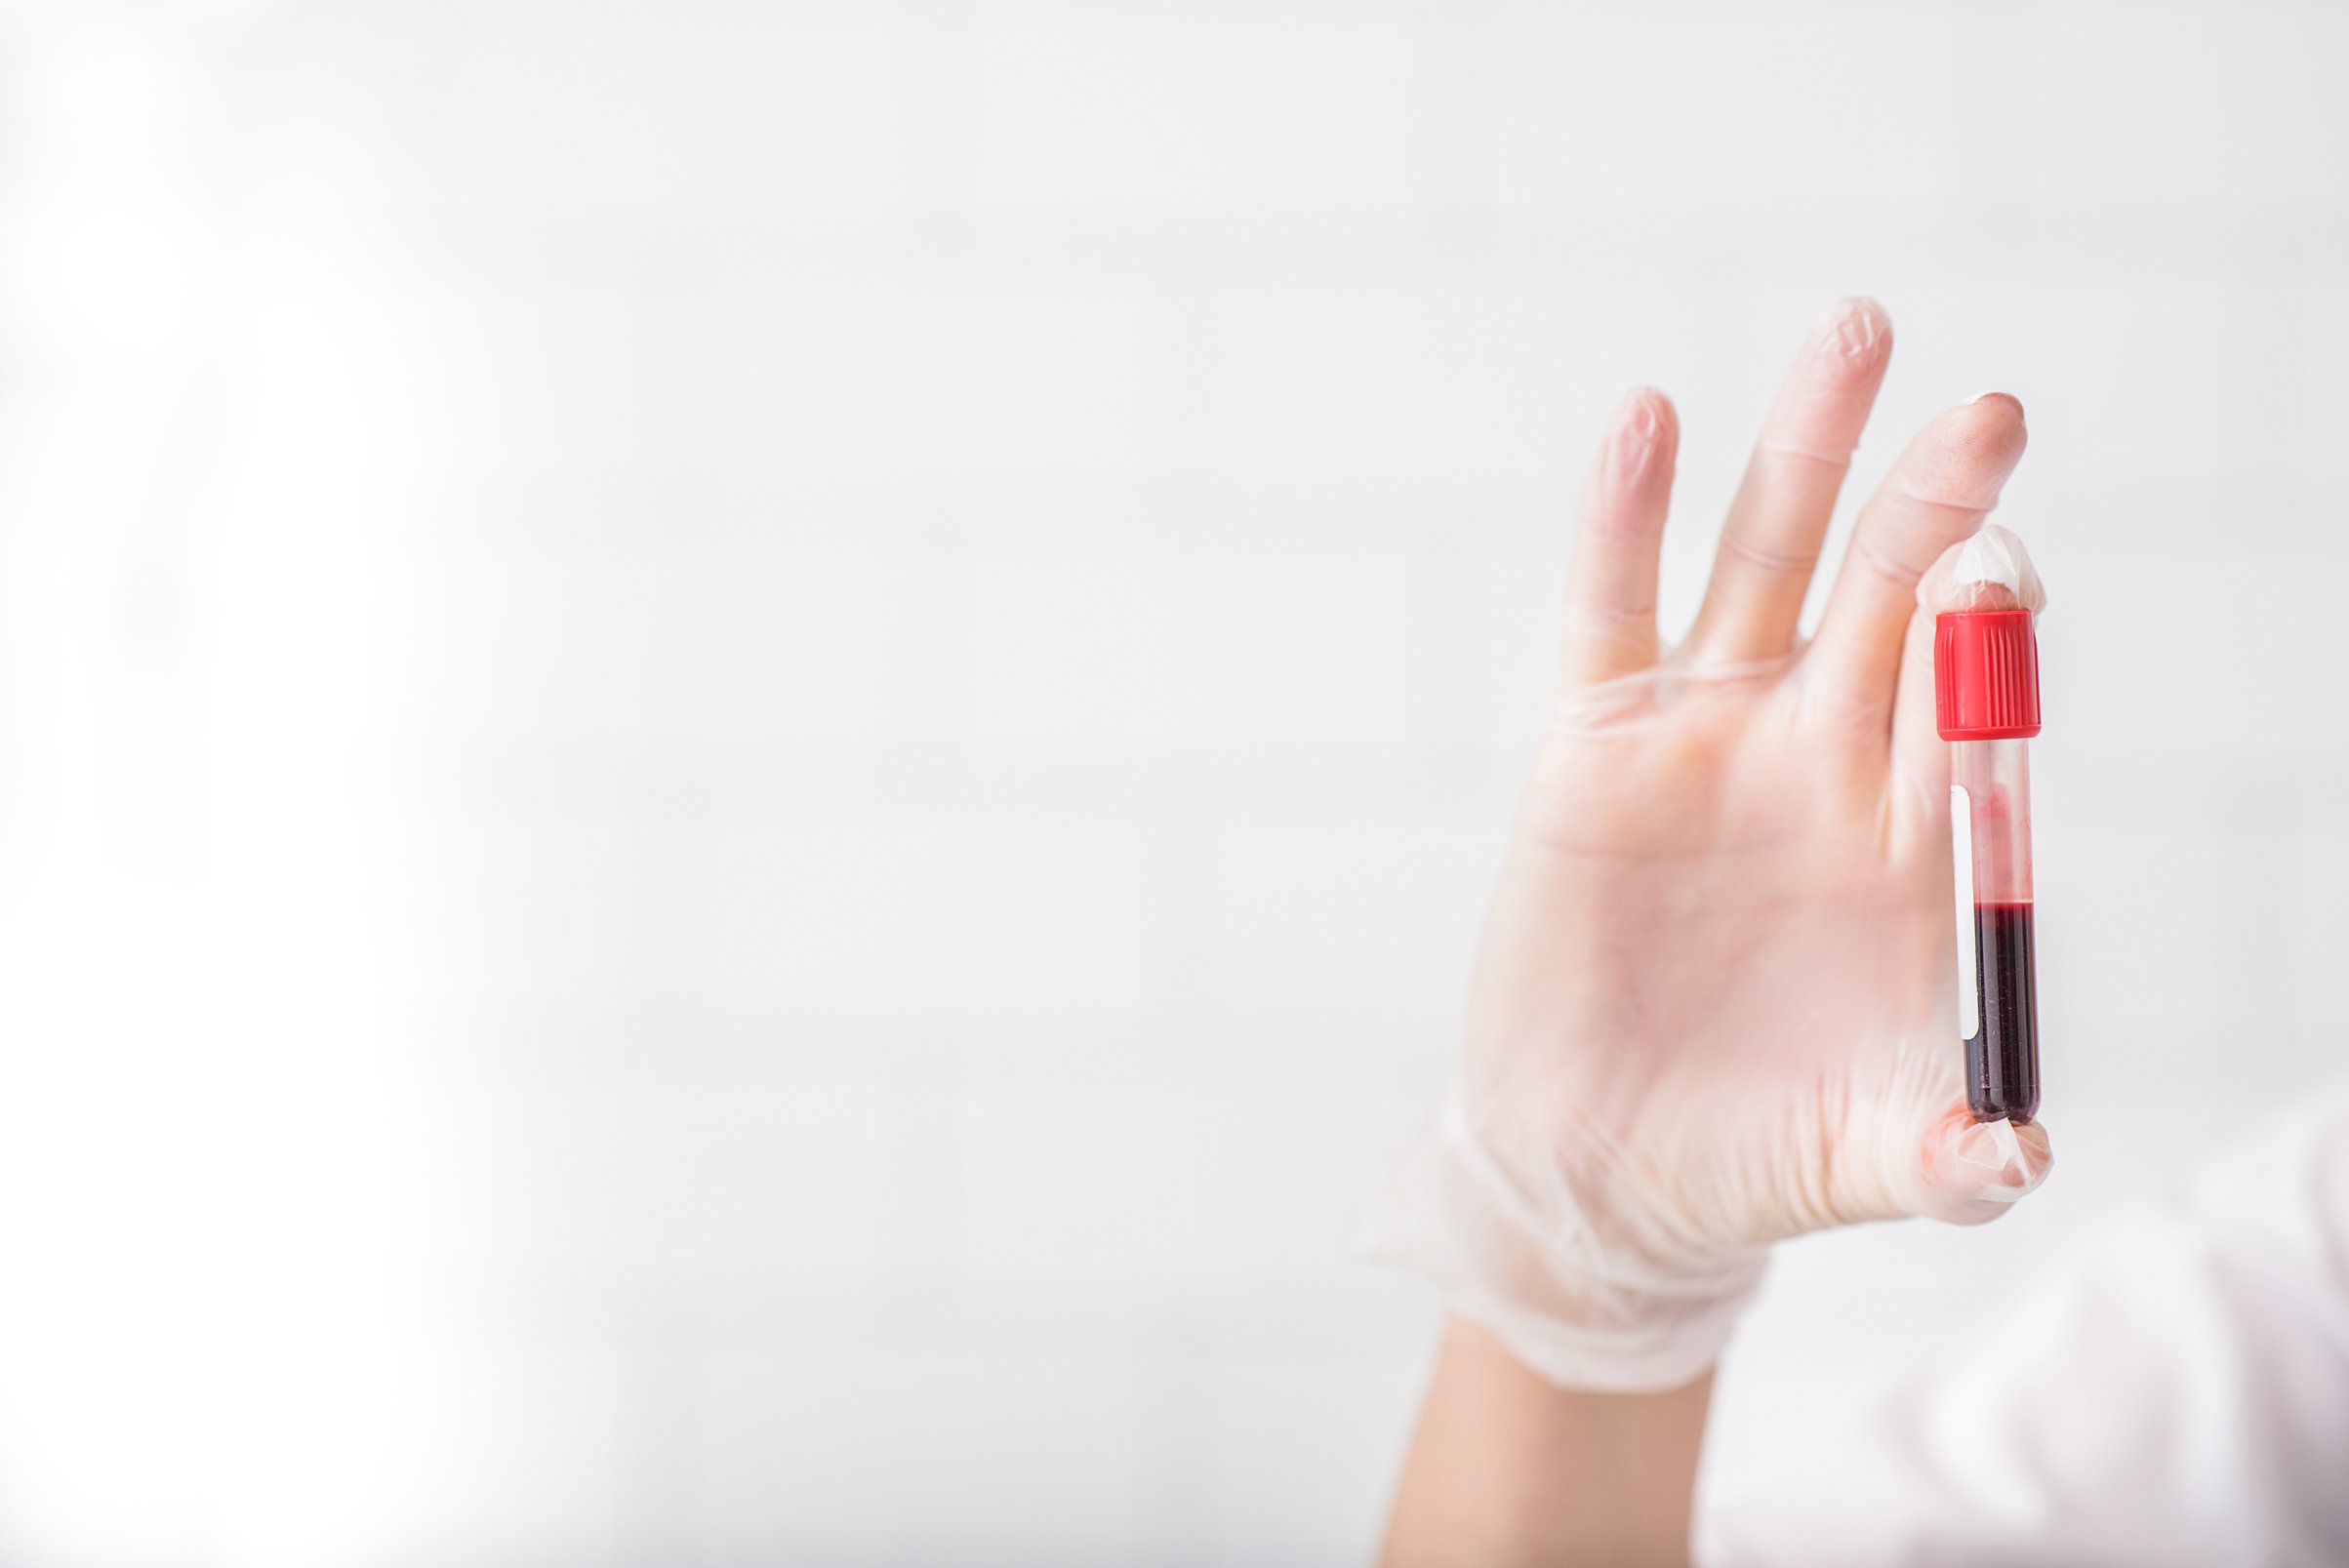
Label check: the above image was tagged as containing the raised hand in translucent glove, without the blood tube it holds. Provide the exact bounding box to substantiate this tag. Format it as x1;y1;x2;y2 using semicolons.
1367;301;2050;1392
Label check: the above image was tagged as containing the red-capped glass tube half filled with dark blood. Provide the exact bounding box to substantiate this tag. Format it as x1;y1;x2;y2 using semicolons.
1933;589;2039;1122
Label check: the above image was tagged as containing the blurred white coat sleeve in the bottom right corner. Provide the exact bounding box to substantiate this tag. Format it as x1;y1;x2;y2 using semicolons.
1696;1080;2349;1568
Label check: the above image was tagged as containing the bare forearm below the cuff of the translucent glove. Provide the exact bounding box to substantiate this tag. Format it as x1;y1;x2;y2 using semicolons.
1381;1317;1713;1568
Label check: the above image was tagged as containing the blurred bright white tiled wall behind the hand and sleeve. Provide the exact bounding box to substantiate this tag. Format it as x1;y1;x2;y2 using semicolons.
0;0;2349;1568
